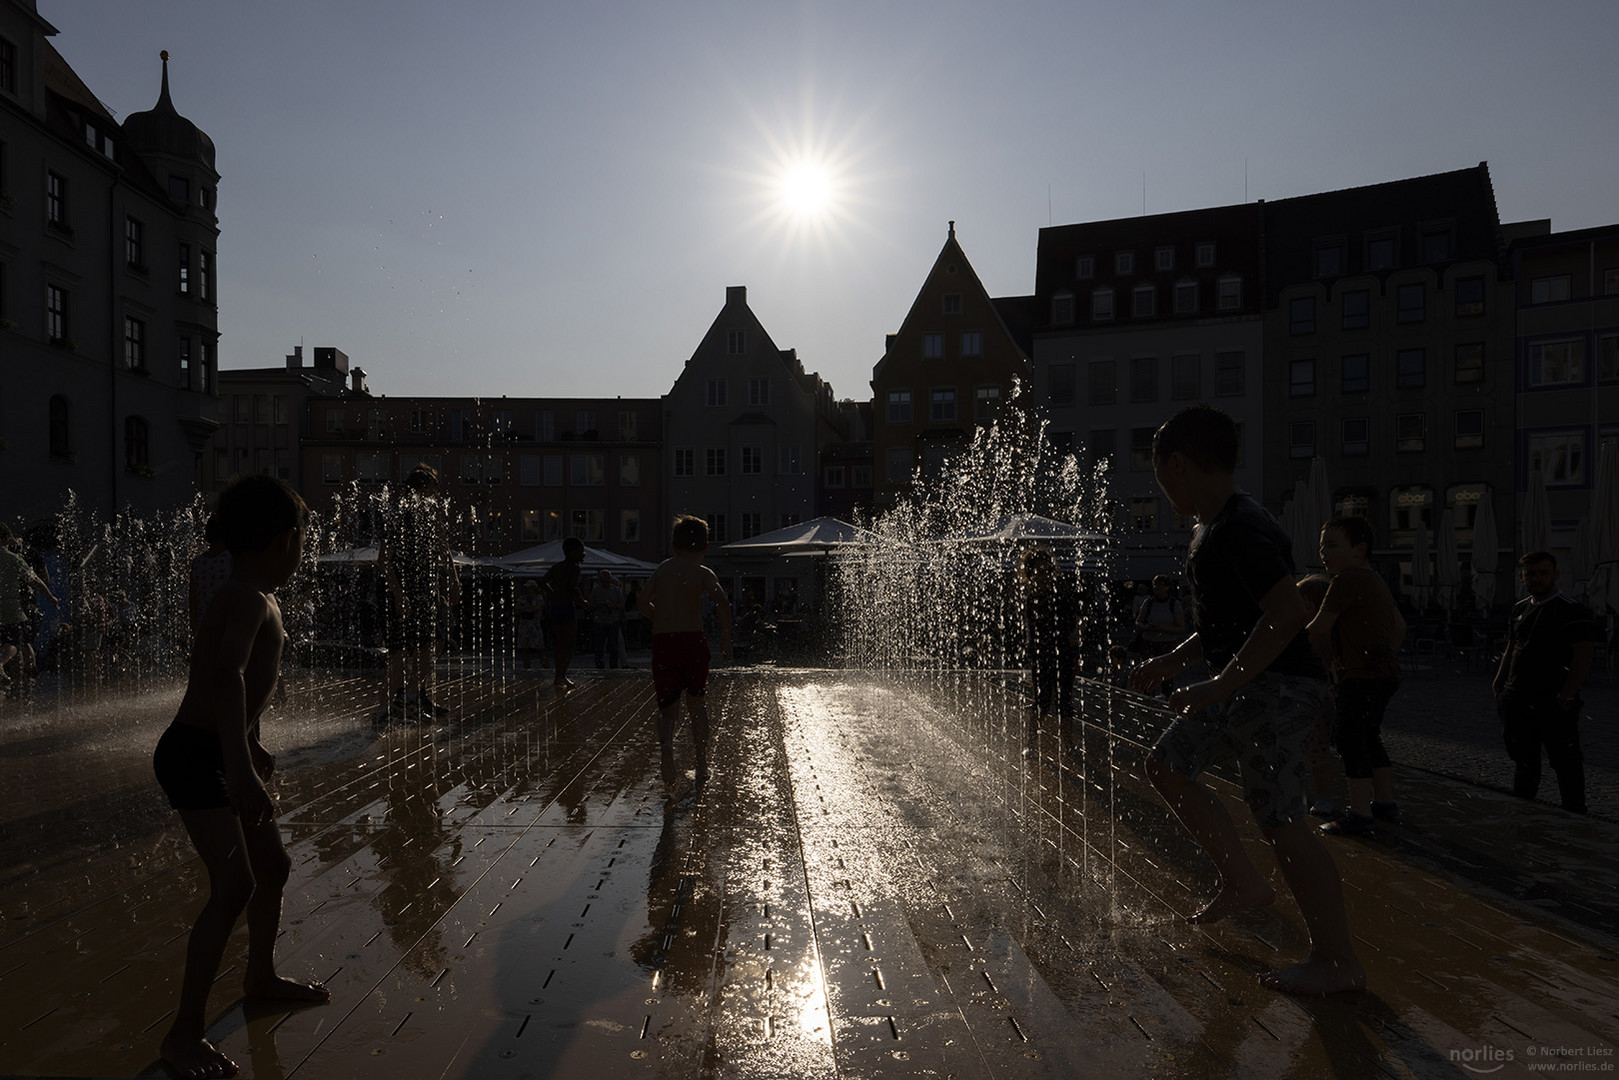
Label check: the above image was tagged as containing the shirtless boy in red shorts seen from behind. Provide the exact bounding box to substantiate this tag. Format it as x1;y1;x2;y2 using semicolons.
638;515;730;789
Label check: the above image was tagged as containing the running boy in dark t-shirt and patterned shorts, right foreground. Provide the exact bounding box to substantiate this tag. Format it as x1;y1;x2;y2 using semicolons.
1130;405;1366;994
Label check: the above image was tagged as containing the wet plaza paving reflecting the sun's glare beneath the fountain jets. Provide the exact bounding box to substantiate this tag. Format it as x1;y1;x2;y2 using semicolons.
0;670;1619;1078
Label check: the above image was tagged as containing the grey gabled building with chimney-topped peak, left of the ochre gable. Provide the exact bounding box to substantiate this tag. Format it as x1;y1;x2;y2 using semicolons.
656;285;848;604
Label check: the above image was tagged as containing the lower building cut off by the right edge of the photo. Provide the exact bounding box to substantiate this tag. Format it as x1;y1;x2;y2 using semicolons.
1511;222;1619;569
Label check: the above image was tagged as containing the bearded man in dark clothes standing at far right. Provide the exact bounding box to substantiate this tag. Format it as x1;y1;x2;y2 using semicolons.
1494;551;1600;814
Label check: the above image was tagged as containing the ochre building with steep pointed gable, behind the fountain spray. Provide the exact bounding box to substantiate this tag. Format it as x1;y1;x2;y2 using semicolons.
871;222;1031;512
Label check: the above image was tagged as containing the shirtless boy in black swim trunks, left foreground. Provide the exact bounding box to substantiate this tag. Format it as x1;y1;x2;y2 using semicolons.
152;476;330;1077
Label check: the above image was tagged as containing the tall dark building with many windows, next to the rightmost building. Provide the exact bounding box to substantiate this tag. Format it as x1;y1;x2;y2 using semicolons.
1264;162;1517;596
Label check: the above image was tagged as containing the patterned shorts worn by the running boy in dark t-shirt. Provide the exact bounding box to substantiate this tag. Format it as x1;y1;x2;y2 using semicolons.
1153;672;1328;829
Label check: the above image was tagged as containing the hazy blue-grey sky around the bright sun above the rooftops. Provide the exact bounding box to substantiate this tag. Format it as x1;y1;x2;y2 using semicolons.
39;0;1619;398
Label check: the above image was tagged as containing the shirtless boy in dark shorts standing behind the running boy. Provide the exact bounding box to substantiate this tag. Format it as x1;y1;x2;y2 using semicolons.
1308;518;1405;836
